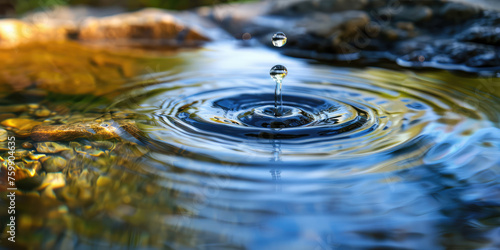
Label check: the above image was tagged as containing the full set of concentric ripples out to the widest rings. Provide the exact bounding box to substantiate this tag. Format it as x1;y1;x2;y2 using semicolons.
116;61;496;161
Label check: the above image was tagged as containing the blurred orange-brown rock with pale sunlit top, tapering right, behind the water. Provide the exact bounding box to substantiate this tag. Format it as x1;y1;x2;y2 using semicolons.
78;9;209;42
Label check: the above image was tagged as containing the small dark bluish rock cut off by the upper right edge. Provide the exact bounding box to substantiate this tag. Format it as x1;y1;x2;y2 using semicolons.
457;26;500;46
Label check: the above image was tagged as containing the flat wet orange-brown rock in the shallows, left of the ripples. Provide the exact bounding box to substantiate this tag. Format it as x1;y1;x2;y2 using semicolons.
31;121;139;141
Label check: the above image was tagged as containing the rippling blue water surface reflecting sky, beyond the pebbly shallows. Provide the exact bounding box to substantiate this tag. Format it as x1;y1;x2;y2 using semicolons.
2;44;500;249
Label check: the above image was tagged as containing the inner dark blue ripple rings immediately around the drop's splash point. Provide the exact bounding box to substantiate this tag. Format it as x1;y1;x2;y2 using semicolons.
162;87;378;140
